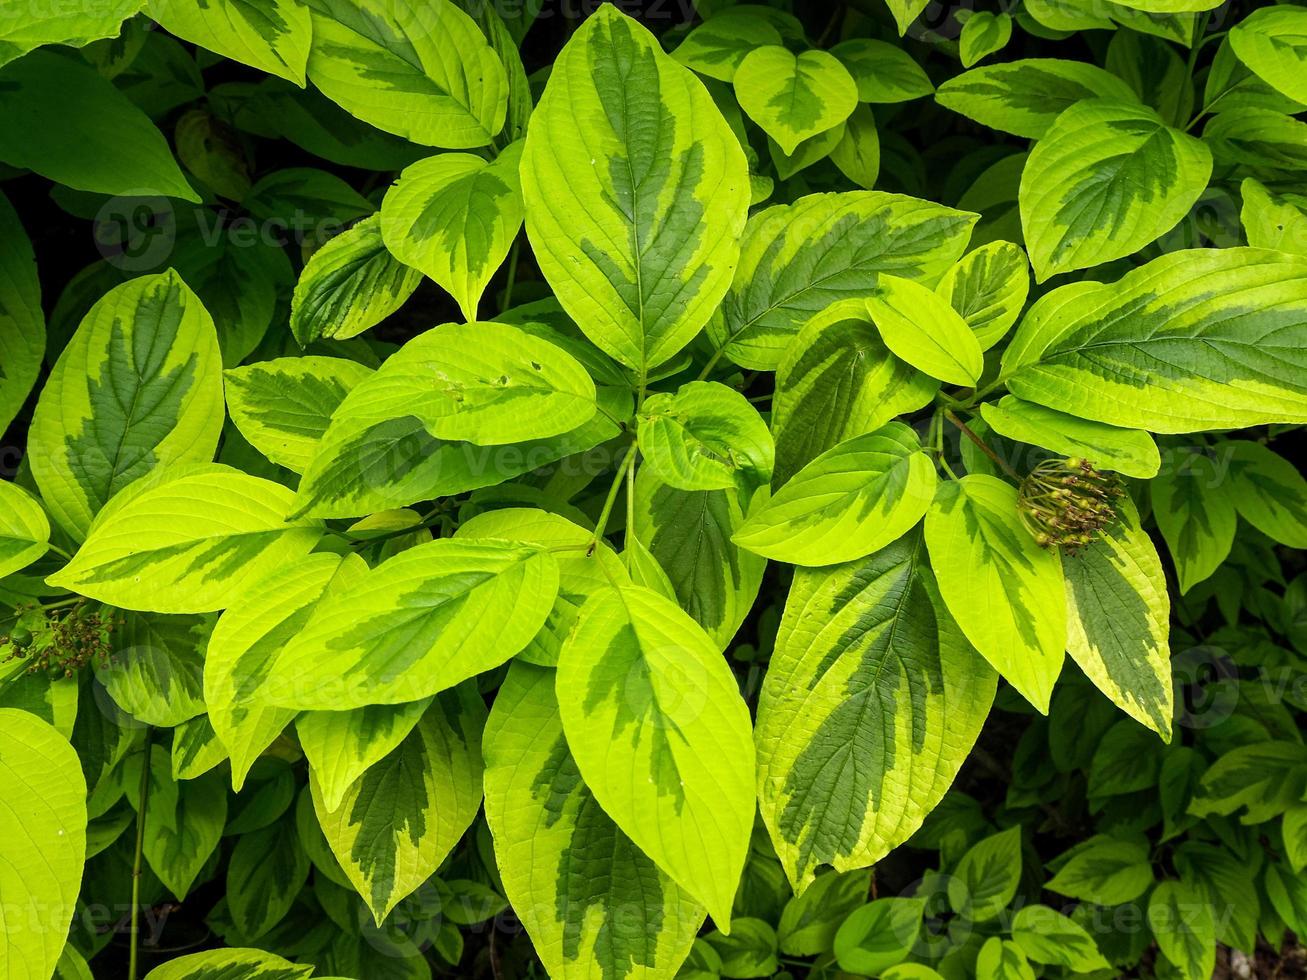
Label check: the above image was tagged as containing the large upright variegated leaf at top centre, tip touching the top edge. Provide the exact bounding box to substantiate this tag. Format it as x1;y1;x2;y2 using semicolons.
521;4;749;372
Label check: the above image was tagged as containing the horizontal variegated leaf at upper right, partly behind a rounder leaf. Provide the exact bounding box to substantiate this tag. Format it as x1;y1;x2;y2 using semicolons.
935;57;1137;140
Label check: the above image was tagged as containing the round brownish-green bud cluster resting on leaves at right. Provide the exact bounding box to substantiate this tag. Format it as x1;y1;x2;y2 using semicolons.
1018;457;1125;551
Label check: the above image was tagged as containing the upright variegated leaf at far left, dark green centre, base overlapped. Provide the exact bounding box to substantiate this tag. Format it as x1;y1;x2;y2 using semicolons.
27;272;222;540
